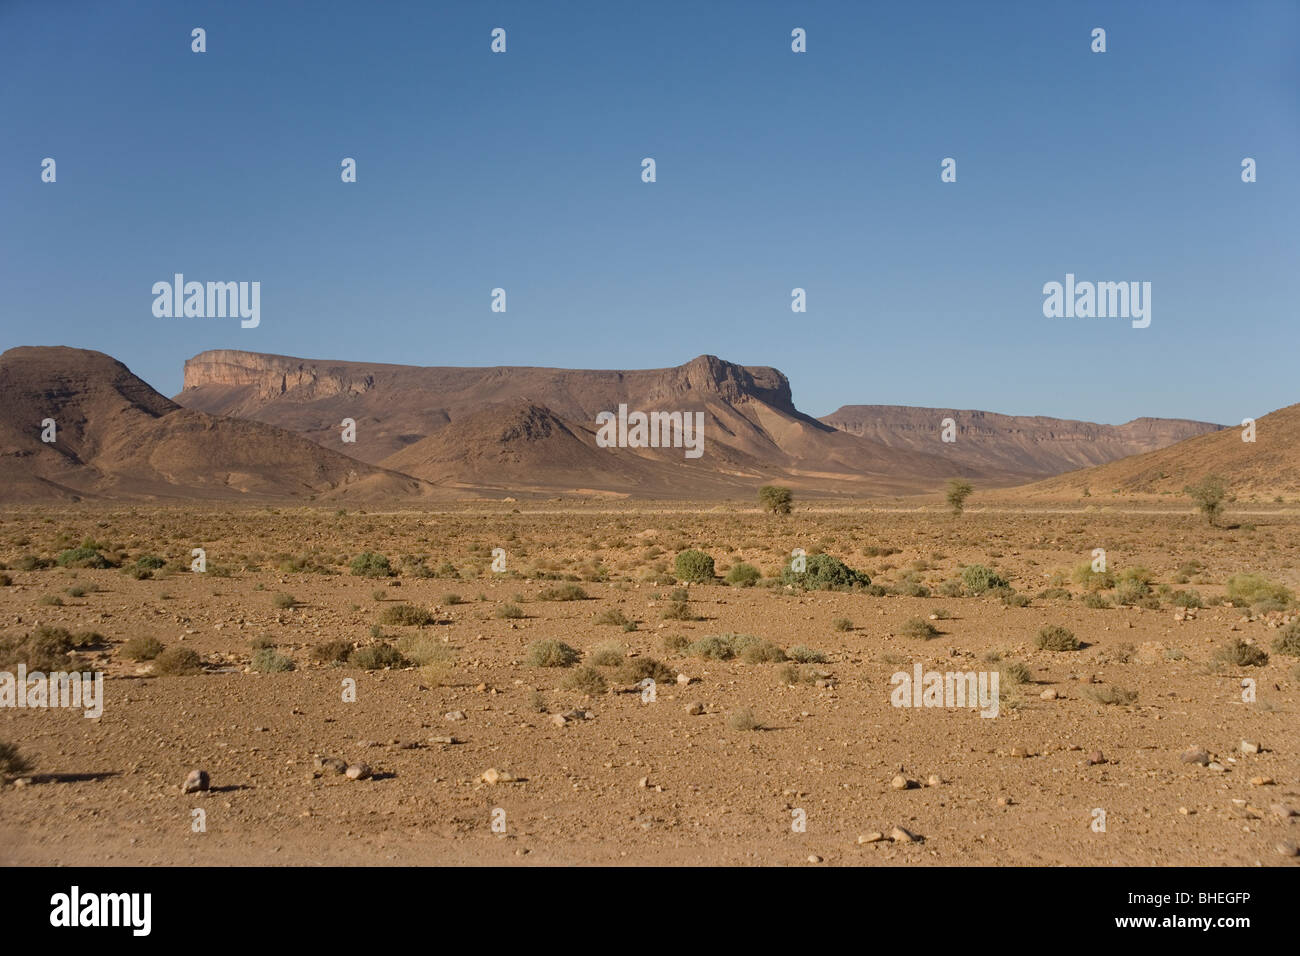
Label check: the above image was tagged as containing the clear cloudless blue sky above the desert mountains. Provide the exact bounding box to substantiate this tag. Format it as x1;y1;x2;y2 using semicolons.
0;0;1300;423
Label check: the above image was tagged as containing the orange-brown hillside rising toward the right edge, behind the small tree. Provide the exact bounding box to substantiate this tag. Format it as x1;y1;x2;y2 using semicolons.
1015;405;1300;498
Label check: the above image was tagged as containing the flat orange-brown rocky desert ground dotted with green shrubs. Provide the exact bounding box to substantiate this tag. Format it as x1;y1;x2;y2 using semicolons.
0;497;1300;866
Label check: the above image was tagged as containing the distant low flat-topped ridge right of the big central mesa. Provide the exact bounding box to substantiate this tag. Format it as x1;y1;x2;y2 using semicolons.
822;405;1219;479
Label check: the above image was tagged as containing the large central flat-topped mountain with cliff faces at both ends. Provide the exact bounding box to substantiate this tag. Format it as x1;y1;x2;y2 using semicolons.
177;351;982;497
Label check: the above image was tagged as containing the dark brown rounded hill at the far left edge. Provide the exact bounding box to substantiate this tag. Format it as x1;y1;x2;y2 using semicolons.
0;347;432;499
